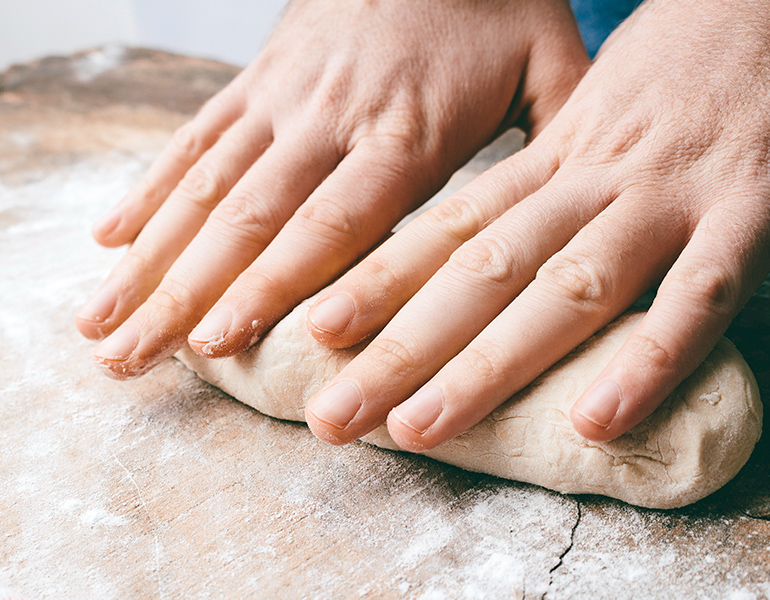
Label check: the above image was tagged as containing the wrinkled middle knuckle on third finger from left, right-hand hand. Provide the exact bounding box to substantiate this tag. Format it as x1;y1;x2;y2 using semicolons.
535;253;612;307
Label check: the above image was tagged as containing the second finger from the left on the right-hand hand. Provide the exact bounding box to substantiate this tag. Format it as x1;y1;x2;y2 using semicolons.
306;166;598;443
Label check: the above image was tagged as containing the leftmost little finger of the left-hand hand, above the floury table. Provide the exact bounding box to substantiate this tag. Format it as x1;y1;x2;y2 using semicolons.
92;81;245;247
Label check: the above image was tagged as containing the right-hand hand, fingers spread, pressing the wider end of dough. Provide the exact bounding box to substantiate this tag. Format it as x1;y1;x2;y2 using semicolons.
306;0;770;451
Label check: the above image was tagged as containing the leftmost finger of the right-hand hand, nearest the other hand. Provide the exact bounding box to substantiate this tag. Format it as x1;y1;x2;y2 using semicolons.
308;139;556;348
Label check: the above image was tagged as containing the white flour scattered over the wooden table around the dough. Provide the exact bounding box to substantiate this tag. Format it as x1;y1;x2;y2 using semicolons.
0;113;767;600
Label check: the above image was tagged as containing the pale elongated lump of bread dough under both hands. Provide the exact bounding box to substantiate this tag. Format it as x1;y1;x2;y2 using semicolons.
178;301;762;508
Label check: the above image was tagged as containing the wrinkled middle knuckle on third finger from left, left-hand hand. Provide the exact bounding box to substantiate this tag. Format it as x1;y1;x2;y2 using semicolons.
211;192;280;247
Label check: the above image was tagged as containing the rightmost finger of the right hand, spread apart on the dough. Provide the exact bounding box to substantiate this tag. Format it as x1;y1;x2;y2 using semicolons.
570;206;770;441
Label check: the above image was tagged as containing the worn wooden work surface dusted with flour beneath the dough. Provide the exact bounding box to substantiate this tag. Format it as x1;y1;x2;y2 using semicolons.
0;48;770;600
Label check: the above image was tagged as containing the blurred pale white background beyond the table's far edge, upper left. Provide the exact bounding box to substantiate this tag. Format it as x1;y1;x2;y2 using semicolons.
0;0;285;70
